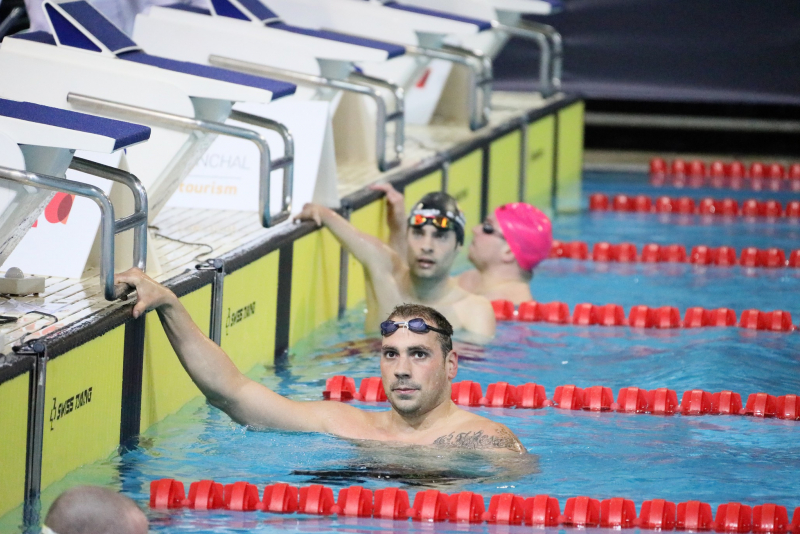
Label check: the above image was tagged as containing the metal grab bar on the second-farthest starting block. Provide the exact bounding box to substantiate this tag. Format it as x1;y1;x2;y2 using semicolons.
394;45;494;131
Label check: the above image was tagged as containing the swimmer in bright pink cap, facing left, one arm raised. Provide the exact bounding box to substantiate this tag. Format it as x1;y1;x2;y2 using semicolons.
372;183;553;305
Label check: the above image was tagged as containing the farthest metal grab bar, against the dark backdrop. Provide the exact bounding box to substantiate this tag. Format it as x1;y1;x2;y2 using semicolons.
492;19;564;96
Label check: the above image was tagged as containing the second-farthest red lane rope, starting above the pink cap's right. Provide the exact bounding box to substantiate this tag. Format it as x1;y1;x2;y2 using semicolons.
589;193;800;221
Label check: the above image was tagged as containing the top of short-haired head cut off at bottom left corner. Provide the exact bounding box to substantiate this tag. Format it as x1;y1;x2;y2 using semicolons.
44;486;147;534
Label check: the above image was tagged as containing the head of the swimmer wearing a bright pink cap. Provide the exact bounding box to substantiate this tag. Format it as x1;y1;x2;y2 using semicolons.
468;202;553;282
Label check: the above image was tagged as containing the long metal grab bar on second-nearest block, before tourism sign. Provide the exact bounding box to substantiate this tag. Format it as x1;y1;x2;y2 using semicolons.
67;93;292;228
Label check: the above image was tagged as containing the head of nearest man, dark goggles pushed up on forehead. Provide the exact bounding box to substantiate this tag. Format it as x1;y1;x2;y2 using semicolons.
381;304;458;419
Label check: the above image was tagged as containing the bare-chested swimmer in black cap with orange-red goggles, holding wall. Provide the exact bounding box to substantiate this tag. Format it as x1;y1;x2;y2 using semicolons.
295;193;495;338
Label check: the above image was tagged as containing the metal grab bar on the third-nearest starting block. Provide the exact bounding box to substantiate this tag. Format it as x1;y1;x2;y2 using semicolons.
208;54;405;172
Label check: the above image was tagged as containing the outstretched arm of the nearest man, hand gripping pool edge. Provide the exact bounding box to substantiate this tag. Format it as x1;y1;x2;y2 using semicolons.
115;268;359;433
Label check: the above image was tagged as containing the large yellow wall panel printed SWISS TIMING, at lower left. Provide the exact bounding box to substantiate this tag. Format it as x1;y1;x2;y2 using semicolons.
42;326;125;494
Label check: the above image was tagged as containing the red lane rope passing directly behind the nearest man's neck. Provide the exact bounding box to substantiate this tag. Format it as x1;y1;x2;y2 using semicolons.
322;375;800;421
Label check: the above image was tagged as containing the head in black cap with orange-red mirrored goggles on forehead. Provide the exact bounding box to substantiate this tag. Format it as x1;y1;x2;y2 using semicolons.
406;192;466;279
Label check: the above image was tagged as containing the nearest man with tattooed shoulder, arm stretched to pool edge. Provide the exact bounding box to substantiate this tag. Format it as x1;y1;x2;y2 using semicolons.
115;268;526;453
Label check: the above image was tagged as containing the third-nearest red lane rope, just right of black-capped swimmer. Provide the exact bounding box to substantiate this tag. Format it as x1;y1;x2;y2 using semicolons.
492;300;796;332
